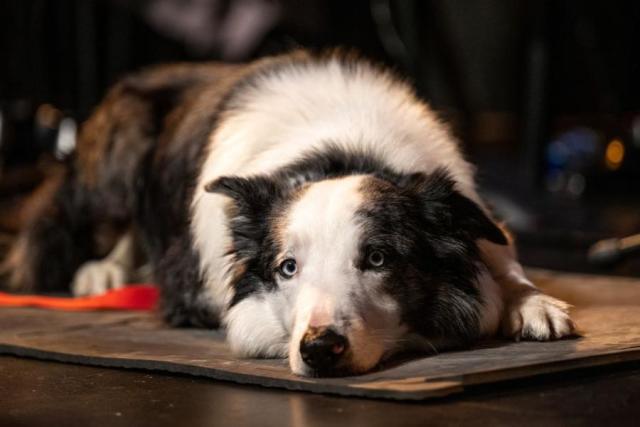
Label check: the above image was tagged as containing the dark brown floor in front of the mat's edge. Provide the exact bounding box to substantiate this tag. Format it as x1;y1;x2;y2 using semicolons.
0;356;640;427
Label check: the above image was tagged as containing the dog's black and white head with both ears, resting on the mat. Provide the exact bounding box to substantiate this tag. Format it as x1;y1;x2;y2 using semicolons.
207;166;506;375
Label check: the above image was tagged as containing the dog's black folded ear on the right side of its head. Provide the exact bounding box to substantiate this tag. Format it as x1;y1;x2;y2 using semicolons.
404;168;508;245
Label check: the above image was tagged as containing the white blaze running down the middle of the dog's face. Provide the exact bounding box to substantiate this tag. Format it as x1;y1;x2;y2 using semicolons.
282;176;363;374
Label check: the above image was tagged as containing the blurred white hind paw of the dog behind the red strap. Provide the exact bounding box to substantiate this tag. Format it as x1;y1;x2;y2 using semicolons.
71;260;128;296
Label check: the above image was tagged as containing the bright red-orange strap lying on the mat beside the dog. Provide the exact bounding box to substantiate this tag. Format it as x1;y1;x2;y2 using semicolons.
0;285;159;311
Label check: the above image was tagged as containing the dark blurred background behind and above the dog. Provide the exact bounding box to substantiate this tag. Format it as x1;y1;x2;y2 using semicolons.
0;0;640;274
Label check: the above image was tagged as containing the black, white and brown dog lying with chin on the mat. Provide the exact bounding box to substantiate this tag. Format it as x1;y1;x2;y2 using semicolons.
3;51;574;376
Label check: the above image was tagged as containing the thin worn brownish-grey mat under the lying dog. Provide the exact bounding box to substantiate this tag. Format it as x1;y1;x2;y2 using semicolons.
0;270;640;400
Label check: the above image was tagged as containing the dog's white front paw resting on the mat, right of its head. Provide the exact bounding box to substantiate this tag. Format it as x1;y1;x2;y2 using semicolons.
503;292;575;341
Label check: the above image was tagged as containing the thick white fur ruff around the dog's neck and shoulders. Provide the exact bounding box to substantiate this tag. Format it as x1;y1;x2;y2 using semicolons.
192;60;480;316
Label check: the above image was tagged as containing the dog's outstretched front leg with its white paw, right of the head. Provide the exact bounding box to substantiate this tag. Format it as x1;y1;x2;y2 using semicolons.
478;240;575;341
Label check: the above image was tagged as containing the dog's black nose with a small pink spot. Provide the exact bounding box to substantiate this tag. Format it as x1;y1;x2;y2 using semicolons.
300;328;347;370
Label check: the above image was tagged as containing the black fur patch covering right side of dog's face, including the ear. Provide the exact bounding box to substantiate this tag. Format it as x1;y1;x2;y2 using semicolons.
360;169;506;345
